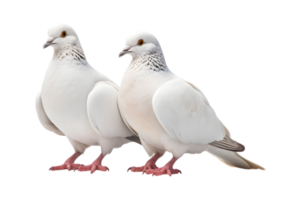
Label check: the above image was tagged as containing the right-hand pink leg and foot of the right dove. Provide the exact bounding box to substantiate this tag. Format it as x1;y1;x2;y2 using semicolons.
145;157;179;177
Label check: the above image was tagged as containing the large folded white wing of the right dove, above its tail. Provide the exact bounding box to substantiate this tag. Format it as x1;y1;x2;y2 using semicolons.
152;79;225;144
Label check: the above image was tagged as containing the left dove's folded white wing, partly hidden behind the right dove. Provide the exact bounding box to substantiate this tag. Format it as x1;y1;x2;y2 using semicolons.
87;81;136;140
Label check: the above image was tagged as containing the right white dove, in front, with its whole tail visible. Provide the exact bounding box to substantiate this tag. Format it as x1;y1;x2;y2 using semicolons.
118;29;264;177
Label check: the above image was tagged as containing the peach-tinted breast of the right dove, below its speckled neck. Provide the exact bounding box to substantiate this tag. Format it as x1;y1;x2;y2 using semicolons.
118;68;174;148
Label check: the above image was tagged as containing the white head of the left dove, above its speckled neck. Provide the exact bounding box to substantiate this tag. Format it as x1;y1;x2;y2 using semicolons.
43;22;78;51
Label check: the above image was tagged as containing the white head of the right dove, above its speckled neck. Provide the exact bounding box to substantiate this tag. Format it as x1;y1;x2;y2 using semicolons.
119;30;160;60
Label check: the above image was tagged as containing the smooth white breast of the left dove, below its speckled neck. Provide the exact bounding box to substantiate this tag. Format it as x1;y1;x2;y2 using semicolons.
41;61;104;144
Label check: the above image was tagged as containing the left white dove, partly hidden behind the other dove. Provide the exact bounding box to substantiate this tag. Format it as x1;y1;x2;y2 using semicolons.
34;22;139;173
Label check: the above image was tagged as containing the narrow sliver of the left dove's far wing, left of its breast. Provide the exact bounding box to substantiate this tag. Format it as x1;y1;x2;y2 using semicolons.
34;87;68;142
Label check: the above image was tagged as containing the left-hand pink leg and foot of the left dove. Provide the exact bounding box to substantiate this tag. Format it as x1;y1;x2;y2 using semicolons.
48;152;83;172
